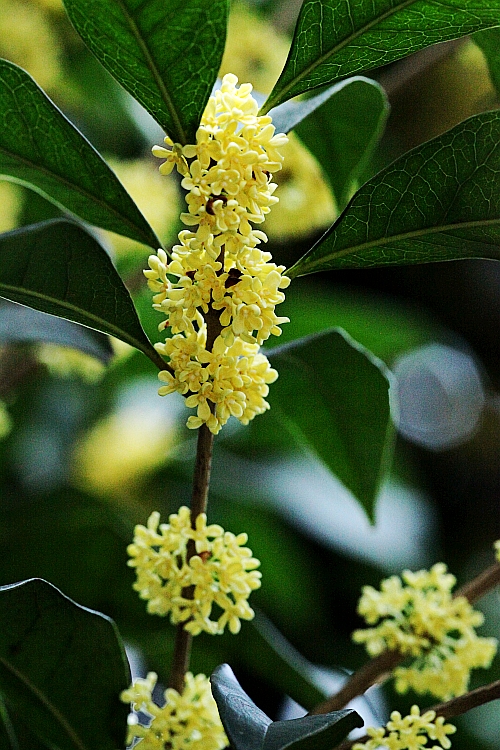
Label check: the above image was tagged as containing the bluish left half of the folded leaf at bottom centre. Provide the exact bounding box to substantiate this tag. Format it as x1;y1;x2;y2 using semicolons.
210;664;272;750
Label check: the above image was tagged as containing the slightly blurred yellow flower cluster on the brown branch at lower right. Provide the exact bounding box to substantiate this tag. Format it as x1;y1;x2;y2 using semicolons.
353;563;497;700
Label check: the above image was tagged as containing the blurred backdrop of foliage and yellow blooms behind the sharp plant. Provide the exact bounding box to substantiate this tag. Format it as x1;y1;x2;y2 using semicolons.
0;0;500;750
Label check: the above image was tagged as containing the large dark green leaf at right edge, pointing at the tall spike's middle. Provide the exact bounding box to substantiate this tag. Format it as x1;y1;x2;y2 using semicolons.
287;112;500;278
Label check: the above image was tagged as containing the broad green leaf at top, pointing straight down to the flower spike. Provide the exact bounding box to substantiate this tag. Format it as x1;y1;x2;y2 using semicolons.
64;0;228;144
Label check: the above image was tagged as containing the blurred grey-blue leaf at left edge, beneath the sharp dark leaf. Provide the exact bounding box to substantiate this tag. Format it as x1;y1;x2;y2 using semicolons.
0;299;113;364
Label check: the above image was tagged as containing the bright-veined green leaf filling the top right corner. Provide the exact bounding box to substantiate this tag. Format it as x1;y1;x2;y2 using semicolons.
261;0;499;113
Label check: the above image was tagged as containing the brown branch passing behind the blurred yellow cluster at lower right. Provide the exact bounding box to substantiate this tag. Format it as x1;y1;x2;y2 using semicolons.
311;562;500;714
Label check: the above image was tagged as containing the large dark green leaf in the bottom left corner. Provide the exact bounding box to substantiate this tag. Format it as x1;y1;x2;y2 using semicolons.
0;579;130;750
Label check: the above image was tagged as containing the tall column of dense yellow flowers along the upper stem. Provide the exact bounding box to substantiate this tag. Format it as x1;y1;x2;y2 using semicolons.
144;74;290;434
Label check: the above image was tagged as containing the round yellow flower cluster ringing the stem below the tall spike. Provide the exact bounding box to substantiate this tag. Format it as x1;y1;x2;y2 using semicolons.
128;506;261;635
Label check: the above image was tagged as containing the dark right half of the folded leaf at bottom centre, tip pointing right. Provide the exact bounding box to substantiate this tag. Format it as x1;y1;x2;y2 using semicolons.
263;709;363;750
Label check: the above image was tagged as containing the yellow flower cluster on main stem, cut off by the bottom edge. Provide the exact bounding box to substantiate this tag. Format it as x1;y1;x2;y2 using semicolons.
120;672;229;750
